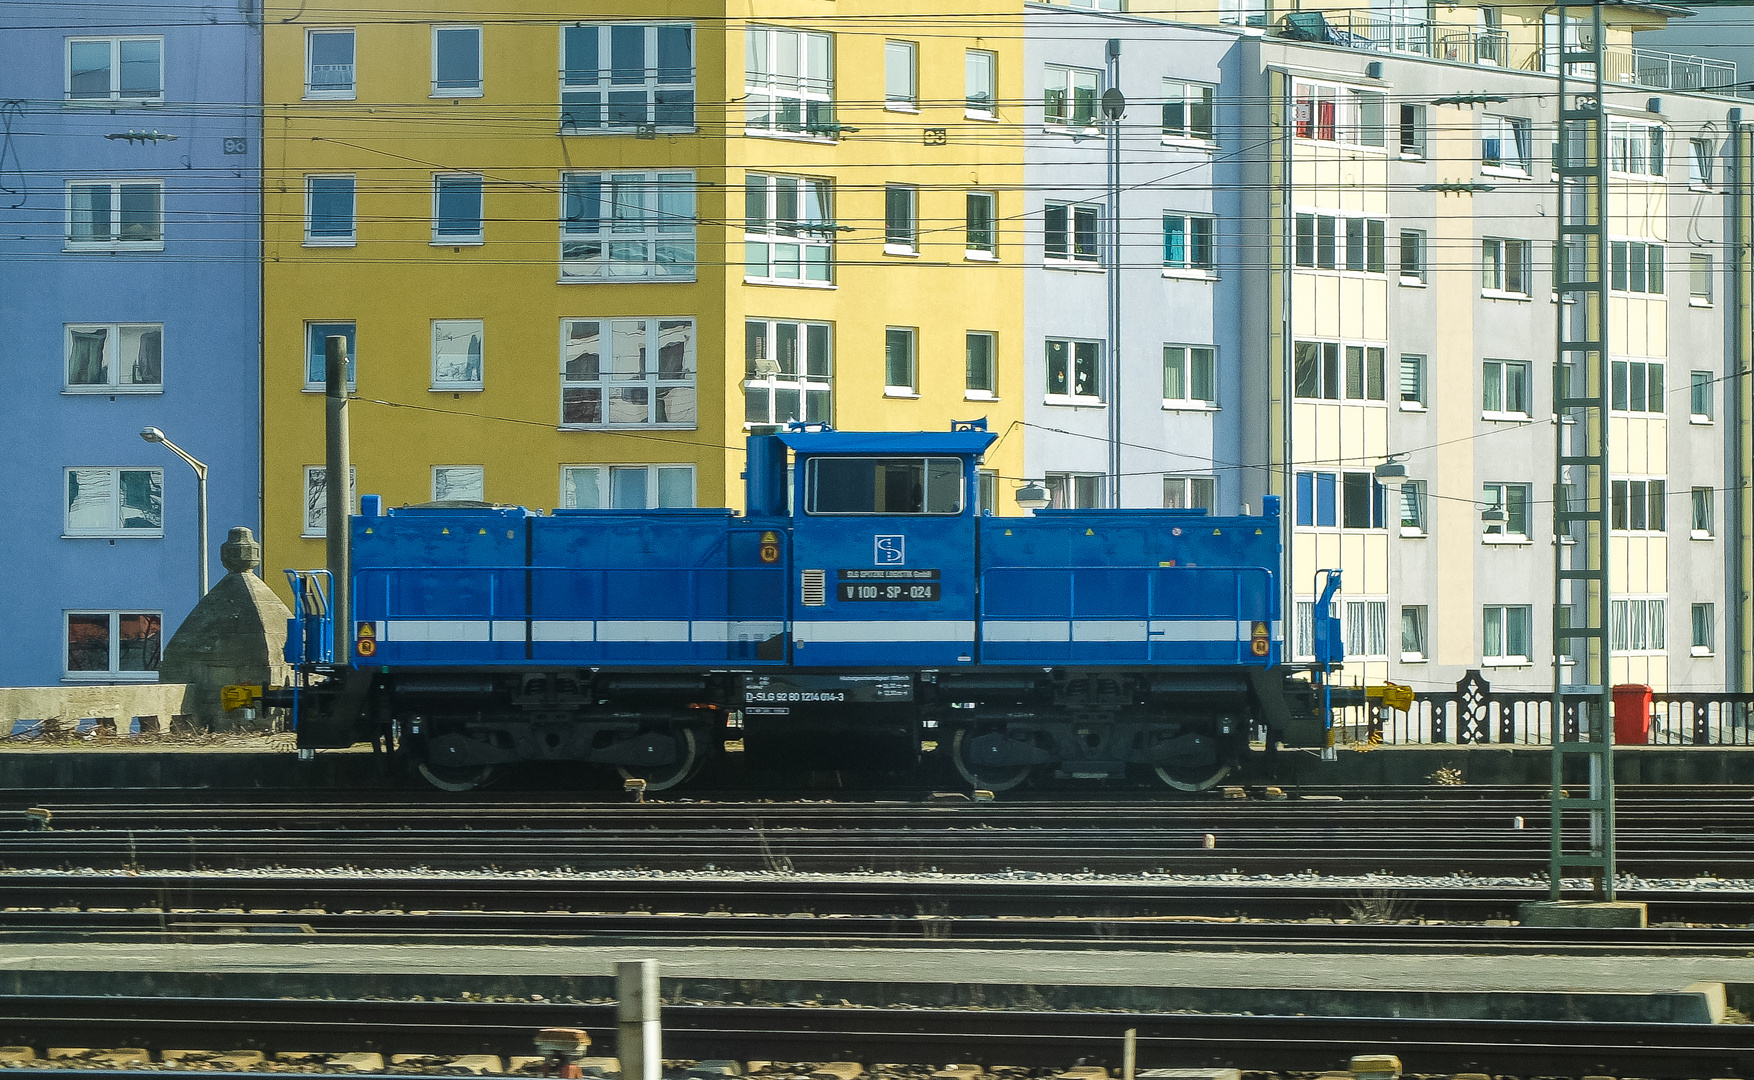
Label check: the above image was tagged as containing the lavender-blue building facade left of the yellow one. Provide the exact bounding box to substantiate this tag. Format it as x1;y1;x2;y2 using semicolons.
0;0;261;686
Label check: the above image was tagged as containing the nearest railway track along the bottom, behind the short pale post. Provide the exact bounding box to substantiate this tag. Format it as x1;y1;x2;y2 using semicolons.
0;996;1754;1080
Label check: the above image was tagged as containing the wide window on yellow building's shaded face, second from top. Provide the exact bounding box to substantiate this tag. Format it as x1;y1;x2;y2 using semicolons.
560;172;695;281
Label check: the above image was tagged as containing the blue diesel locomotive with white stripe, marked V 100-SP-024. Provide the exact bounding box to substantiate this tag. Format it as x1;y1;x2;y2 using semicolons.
265;421;1338;791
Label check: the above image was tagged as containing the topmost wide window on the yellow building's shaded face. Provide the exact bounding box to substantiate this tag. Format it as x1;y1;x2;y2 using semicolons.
560;23;695;133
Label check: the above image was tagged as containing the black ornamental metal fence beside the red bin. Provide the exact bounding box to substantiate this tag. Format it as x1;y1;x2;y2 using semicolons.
1333;671;1754;747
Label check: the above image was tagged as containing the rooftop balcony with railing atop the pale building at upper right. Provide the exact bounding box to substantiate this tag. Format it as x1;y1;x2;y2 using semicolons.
1279;11;1736;93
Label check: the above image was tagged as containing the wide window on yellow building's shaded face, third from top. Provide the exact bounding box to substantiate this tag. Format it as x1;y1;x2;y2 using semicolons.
560;319;696;428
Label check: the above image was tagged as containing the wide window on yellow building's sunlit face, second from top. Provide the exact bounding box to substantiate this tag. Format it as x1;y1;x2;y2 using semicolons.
744;172;835;284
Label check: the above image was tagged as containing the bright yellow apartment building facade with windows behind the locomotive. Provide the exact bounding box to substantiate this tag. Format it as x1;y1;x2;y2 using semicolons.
263;0;1023;596
